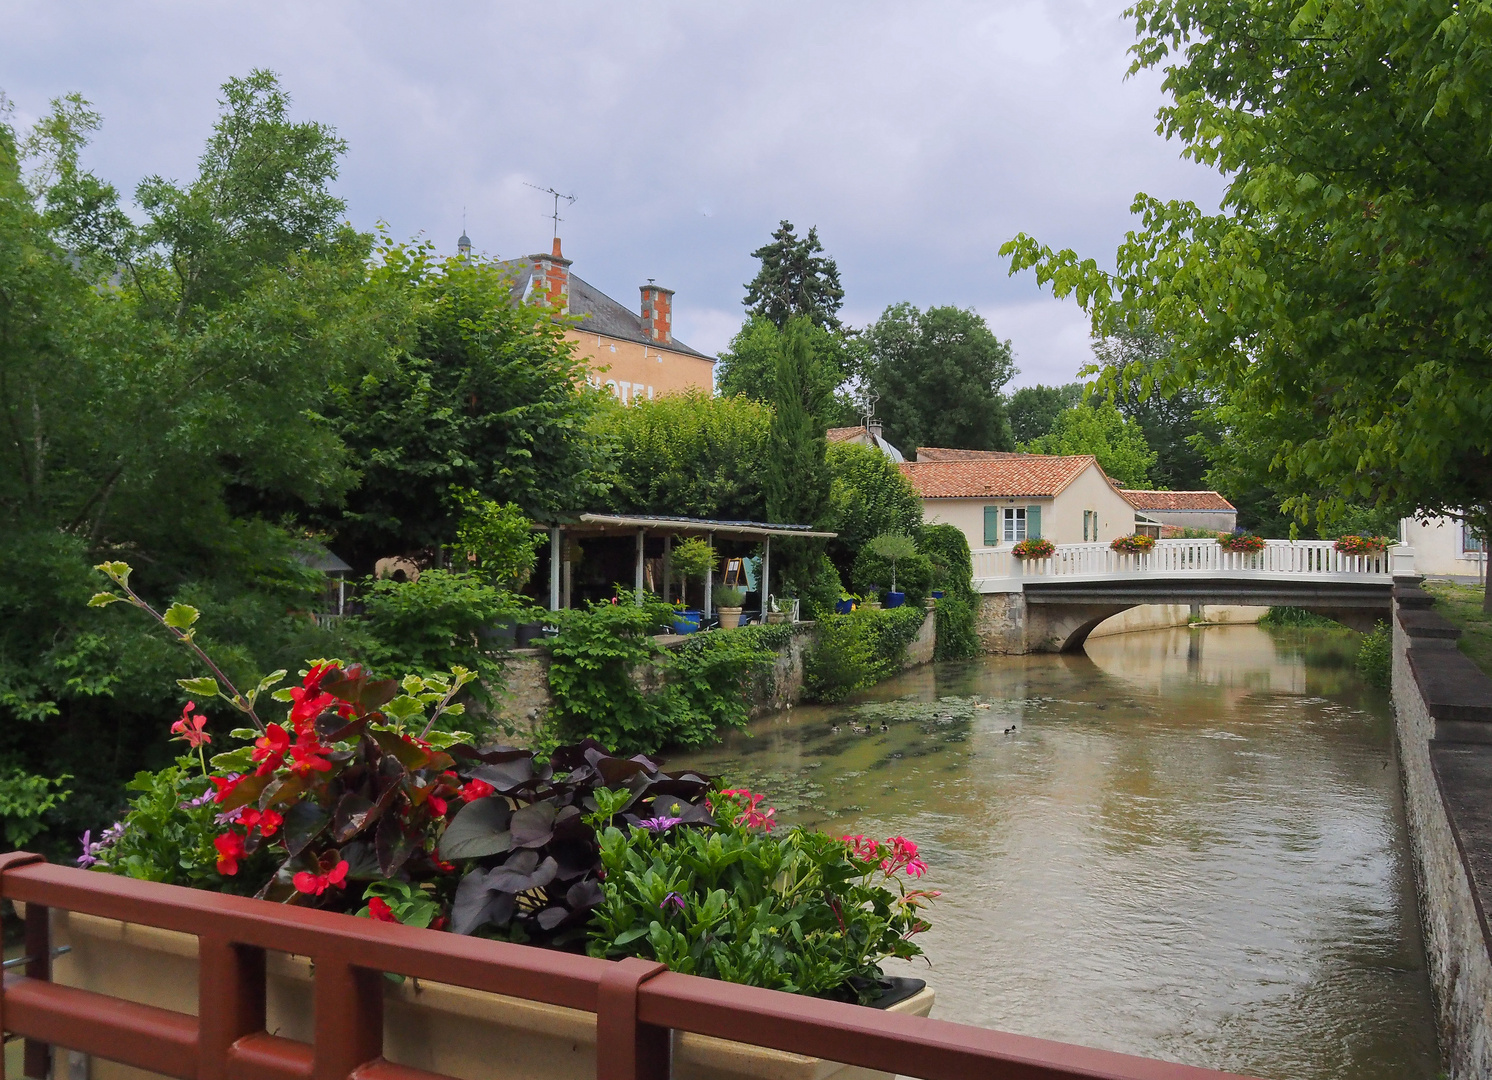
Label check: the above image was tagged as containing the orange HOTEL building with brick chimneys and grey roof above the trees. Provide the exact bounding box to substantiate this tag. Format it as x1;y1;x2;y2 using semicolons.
495;234;715;404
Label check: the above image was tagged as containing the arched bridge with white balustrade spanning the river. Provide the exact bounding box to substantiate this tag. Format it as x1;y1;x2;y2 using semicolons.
973;540;1414;652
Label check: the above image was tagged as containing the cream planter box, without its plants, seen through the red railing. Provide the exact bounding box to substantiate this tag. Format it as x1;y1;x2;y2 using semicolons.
40;904;934;1080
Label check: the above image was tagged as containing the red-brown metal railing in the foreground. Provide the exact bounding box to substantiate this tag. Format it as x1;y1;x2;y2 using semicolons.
0;852;1259;1080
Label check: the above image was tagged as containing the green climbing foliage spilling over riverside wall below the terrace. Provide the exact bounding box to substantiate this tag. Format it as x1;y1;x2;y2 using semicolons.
549;598;773;753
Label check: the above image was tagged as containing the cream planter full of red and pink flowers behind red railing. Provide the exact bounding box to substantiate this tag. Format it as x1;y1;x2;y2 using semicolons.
54;564;937;1080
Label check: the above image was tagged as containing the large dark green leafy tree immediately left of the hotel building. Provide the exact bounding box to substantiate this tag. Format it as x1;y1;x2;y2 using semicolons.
319;246;612;568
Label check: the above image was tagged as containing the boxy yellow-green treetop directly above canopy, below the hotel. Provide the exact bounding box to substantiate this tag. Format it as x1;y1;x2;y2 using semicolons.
592;387;776;521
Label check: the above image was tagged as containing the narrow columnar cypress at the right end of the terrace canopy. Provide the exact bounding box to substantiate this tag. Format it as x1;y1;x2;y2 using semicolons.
762;318;831;586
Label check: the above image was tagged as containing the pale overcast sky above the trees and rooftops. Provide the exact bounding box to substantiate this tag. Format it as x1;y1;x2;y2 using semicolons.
0;0;1220;385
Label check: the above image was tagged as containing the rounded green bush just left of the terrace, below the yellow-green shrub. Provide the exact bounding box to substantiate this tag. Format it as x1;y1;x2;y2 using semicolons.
361;570;522;700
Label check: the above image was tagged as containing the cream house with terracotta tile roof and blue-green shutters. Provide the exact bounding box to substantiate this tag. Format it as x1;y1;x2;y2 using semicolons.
901;448;1134;549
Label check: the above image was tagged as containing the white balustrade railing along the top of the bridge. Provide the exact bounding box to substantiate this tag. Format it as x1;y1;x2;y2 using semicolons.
973;540;1414;582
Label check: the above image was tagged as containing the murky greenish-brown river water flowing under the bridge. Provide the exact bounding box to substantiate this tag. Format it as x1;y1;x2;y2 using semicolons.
668;627;1438;1080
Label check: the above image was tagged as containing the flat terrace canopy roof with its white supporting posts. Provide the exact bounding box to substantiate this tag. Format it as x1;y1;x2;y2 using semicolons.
539;513;839;616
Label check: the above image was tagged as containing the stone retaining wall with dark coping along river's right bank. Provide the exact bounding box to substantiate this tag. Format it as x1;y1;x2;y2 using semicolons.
1394;586;1492;1080
